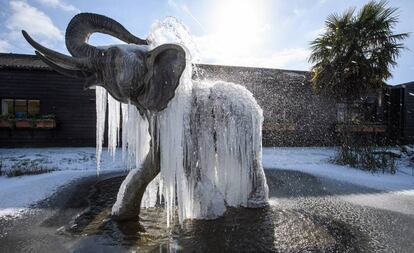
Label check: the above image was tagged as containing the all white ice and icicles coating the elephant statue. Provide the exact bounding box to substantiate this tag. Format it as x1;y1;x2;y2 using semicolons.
96;18;268;225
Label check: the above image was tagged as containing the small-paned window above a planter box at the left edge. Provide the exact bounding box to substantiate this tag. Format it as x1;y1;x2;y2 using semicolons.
1;98;40;119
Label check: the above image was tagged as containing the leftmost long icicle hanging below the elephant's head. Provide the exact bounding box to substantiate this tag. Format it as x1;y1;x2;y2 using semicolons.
95;86;107;175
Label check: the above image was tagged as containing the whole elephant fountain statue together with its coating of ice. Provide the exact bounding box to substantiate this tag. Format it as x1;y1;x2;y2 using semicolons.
23;13;268;224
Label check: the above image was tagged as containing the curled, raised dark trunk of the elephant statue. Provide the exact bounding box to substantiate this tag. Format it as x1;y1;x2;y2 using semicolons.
65;13;148;57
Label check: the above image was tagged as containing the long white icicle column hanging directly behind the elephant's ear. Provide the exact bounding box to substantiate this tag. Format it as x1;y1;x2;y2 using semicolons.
157;63;192;225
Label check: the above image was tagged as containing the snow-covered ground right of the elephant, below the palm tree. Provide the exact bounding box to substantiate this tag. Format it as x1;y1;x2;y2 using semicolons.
263;147;414;196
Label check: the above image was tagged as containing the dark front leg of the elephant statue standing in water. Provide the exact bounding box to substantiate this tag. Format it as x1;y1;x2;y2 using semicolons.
112;151;160;221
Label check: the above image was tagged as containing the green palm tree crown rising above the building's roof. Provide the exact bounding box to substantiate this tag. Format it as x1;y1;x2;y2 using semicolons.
309;1;408;101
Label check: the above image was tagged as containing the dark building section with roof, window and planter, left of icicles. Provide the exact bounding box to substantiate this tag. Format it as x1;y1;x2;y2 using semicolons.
0;54;96;147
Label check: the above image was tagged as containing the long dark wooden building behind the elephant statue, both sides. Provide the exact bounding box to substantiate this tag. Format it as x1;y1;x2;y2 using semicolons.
0;54;408;147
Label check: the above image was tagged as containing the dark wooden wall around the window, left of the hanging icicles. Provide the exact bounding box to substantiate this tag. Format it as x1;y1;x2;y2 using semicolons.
0;68;96;147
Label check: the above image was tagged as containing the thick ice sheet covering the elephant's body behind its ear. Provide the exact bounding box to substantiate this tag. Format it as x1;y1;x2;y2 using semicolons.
158;75;267;224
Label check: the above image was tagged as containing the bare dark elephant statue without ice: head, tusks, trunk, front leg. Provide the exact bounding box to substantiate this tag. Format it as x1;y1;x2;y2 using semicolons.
22;13;267;221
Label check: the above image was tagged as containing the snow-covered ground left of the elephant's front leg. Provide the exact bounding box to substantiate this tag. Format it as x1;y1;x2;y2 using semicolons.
0;148;125;218
